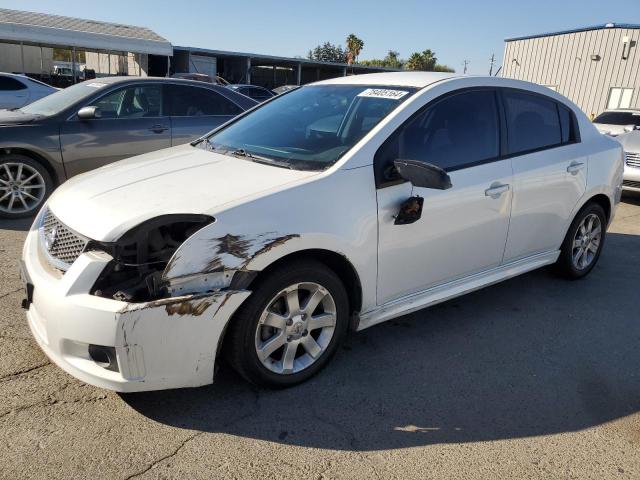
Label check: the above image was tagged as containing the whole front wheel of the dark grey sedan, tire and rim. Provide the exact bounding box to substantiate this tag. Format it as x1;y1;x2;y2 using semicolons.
0;153;53;219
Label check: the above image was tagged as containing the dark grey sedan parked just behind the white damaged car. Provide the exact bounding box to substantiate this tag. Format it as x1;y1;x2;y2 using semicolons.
0;77;257;218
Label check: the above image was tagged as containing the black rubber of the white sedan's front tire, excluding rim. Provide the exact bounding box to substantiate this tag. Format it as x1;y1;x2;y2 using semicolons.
223;260;349;388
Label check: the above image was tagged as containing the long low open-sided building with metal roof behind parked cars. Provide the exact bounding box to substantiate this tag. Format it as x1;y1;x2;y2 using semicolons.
0;8;390;88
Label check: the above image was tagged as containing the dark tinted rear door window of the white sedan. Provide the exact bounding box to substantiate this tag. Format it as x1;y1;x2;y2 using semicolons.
503;90;571;153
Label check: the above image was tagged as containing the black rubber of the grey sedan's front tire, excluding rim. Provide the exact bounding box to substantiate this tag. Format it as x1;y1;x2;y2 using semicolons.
0;153;54;219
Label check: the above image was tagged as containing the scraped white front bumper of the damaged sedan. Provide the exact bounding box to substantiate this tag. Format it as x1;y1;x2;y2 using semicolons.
23;228;250;392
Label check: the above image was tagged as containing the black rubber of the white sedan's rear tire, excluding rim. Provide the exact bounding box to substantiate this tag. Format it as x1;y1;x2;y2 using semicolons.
553;203;607;280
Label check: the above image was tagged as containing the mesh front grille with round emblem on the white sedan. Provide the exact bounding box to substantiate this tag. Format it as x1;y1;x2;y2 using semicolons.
40;209;89;271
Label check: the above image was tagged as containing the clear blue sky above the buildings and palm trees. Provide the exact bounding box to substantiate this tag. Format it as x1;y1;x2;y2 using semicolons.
5;0;640;74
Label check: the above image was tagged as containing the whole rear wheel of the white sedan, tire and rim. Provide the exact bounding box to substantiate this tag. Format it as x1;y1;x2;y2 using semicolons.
554;203;607;280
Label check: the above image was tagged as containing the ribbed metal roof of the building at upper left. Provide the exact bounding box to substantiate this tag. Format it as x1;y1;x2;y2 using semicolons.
0;8;173;55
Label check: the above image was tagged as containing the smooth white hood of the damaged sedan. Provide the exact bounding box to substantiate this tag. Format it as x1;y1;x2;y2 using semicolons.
48;144;318;241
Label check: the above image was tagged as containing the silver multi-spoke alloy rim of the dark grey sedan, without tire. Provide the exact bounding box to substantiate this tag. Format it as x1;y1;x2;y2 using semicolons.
0;162;46;214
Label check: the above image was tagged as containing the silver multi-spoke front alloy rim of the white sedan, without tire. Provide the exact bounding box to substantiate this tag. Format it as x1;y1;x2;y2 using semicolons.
255;282;336;375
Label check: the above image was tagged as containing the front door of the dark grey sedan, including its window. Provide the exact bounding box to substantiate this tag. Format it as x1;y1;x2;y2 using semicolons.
60;83;171;176
